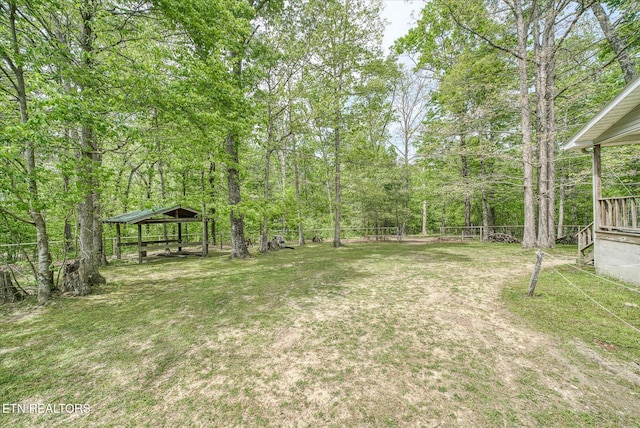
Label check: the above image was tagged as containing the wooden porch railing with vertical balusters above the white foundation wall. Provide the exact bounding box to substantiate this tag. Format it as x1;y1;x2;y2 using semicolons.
598;196;640;233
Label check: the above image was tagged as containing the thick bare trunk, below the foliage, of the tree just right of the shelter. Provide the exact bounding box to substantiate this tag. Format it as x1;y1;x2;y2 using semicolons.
225;134;251;259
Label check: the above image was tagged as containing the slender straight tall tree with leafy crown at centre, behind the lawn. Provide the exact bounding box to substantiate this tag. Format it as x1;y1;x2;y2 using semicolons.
305;0;382;247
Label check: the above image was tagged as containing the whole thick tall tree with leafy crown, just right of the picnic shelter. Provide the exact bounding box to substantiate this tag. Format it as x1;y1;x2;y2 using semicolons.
155;0;270;258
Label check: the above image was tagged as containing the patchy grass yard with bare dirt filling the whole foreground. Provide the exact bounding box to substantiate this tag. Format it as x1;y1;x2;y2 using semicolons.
0;243;640;427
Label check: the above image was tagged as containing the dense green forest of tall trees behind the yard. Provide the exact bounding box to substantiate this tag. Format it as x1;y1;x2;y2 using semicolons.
0;0;640;303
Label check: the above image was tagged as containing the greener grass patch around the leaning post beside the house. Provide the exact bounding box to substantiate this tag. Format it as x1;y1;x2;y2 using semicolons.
503;263;640;362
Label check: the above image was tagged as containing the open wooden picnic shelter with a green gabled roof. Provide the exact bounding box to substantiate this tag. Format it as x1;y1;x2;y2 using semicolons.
102;205;209;263
